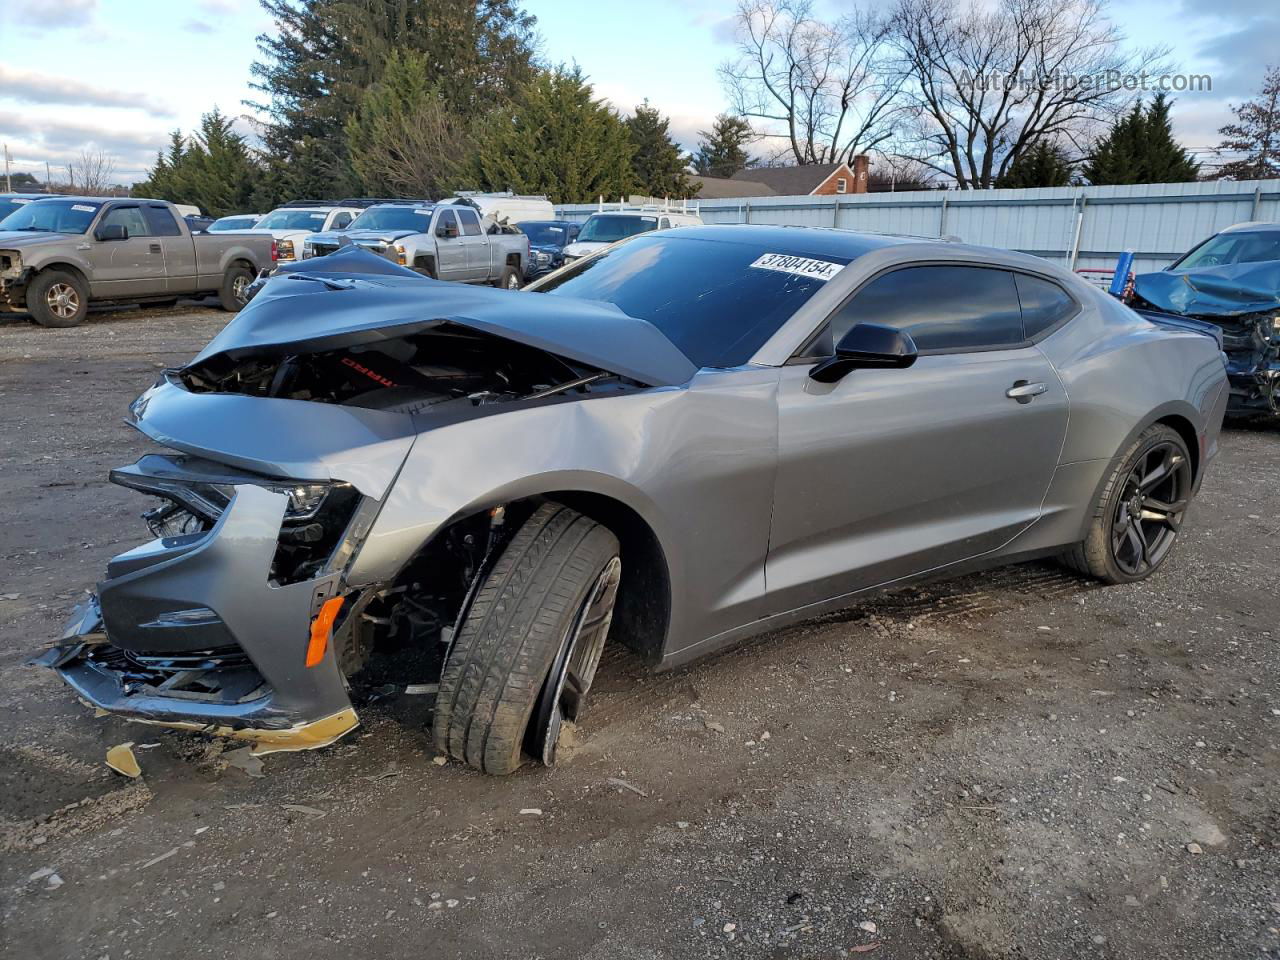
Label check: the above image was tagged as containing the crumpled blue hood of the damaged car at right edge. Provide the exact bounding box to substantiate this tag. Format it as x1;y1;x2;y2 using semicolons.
1134;260;1280;316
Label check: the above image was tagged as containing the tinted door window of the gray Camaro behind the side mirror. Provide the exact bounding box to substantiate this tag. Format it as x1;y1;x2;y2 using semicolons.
831;266;1025;352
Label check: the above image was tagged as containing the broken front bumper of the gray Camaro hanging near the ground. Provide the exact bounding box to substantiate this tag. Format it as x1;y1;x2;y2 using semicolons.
36;456;361;751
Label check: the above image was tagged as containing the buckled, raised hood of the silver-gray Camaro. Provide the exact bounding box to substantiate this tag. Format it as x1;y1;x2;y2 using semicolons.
192;244;698;387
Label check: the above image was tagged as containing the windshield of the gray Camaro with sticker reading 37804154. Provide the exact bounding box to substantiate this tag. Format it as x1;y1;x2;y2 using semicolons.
532;233;849;367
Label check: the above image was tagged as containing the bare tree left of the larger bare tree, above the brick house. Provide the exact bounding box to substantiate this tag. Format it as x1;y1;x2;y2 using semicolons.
719;0;900;164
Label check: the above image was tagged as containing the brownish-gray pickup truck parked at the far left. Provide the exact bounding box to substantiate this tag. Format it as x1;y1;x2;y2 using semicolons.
0;196;275;326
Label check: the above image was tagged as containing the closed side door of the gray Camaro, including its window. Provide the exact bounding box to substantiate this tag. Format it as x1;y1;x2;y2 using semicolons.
765;264;1068;611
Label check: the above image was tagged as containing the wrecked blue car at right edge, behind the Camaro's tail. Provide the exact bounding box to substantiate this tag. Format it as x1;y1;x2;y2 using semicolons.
1130;223;1280;417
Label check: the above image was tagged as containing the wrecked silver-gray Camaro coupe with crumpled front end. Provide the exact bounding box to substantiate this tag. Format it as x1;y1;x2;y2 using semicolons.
40;225;1228;773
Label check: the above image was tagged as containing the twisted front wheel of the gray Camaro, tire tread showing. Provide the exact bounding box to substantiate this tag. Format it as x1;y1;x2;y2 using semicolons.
434;503;621;776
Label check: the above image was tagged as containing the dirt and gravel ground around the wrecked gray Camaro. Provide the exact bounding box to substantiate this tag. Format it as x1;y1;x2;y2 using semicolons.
0;307;1280;960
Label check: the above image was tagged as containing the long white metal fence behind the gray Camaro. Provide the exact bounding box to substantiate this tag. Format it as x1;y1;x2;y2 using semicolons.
557;180;1280;273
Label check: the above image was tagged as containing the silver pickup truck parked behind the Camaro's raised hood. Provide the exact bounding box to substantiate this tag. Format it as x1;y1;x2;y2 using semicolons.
302;201;529;289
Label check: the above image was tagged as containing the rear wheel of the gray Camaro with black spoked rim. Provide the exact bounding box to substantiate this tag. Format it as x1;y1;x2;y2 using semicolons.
1062;424;1193;584
